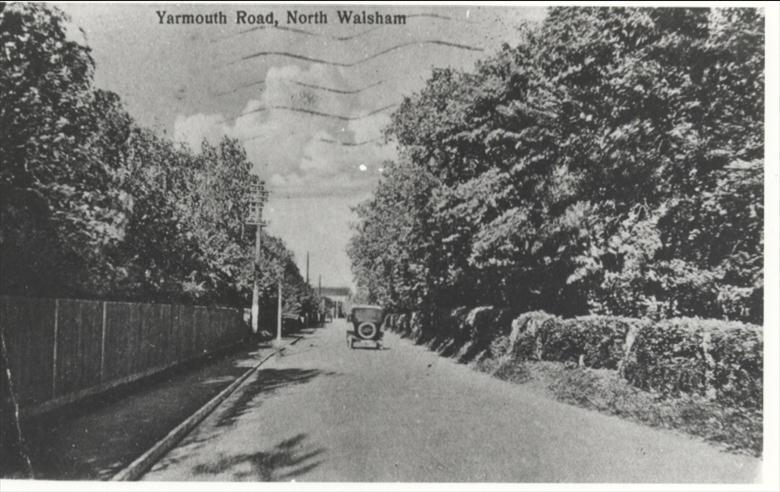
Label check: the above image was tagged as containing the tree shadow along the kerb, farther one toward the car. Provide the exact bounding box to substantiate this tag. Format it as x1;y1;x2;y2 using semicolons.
216;369;336;427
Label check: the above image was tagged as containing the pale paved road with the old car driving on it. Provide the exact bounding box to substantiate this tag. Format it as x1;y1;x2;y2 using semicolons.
145;321;760;483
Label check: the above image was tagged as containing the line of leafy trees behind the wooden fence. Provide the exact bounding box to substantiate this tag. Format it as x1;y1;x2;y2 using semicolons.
0;4;316;311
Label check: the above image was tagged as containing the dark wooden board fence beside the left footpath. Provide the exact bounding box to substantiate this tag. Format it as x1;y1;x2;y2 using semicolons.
0;296;251;415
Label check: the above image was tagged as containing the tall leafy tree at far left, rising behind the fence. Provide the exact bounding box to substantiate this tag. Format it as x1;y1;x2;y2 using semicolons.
0;4;124;294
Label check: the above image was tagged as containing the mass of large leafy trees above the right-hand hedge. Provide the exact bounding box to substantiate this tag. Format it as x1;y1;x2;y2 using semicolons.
350;8;764;323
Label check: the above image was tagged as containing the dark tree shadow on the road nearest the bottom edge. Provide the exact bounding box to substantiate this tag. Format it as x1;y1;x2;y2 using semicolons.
192;434;325;482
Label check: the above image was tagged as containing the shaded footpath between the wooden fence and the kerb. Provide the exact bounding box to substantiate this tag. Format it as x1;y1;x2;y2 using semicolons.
24;336;290;480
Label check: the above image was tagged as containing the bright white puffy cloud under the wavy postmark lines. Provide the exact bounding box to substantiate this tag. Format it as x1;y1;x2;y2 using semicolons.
174;65;396;195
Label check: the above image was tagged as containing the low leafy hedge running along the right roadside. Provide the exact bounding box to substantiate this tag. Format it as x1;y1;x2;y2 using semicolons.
385;306;763;408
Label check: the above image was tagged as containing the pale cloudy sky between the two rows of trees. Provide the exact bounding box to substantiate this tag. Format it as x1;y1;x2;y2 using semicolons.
58;3;545;287
